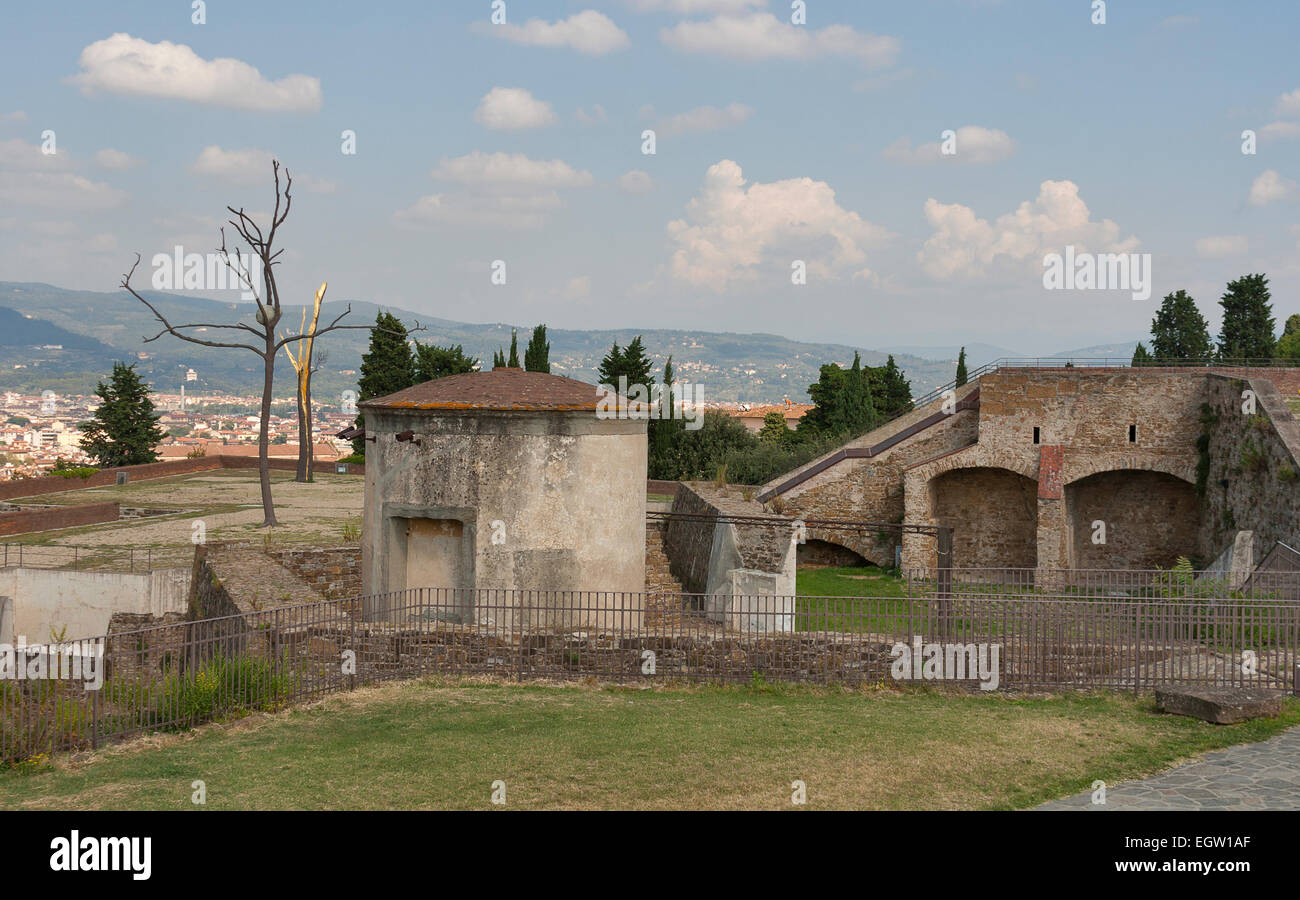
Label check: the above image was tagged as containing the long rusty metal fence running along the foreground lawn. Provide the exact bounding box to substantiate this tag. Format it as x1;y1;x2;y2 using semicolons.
0;588;1300;761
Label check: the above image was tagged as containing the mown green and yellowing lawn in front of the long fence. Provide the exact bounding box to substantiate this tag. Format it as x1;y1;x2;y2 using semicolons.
0;682;1300;809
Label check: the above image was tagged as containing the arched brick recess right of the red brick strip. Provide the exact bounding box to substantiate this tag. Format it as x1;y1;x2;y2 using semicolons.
1065;460;1201;568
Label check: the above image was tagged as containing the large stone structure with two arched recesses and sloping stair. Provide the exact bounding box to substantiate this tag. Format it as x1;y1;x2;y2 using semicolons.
759;367;1300;568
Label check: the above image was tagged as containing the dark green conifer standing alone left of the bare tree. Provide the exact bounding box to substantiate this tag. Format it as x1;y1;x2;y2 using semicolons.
78;363;166;468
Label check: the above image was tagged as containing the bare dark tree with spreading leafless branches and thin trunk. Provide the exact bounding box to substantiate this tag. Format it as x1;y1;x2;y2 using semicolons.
121;160;424;528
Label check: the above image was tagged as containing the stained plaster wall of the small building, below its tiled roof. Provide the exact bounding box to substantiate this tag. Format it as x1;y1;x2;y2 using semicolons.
361;408;646;621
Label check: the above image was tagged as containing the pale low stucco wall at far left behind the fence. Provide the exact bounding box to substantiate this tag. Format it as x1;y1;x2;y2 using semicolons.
0;567;190;642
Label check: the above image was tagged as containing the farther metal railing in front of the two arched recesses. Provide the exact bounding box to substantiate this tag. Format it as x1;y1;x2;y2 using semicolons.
904;566;1300;603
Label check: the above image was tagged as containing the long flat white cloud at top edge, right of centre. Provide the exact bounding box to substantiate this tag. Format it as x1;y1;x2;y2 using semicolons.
659;13;900;68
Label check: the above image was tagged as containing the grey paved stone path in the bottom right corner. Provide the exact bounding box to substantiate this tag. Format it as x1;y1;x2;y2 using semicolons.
1039;727;1300;809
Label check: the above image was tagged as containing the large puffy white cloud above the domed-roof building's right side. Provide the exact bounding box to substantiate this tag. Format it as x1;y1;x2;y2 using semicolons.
667;160;891;291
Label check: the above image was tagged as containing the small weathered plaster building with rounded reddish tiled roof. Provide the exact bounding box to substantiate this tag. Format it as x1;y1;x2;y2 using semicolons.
360;368;646;626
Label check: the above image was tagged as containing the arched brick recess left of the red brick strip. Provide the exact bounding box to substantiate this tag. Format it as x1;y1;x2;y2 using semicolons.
927;466;1039;568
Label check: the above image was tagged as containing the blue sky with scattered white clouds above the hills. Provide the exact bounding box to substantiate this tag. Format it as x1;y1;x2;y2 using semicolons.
0;0;1300;354
